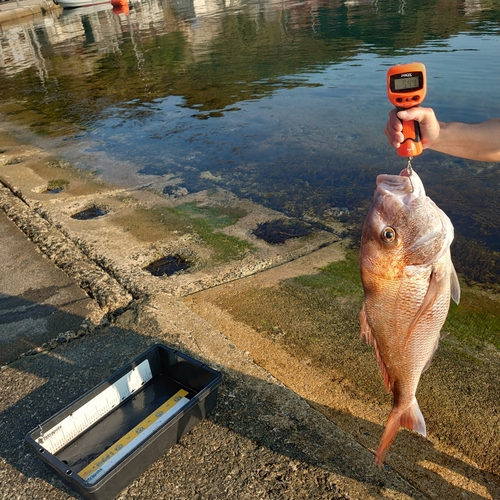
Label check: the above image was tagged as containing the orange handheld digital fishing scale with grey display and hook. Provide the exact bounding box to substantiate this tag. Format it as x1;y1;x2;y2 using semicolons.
387;62;427;162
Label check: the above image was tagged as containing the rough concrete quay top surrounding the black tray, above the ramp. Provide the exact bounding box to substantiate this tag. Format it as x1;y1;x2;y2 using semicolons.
0;201;421;499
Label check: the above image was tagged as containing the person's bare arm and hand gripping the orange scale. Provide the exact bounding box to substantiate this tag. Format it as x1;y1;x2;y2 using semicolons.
385;107;500;162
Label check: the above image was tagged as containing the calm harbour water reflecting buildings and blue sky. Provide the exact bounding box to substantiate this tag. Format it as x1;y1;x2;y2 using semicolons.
0;0;500;283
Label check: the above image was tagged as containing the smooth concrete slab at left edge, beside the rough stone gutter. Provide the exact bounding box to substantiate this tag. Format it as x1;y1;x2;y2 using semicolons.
0;207;99;365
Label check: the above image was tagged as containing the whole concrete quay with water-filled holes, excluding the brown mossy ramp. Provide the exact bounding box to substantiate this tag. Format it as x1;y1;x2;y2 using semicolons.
0;97;430;500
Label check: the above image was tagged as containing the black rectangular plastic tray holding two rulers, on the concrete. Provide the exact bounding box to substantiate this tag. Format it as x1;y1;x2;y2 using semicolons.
25;344;222;500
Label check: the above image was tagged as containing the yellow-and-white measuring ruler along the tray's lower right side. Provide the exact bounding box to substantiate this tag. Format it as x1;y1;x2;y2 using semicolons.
78;389;189;484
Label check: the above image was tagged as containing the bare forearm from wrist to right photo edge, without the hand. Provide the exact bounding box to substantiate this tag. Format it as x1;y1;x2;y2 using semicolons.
428;118;500;162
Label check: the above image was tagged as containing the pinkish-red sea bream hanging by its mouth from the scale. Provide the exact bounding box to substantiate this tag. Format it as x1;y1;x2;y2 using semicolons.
360;170;460;467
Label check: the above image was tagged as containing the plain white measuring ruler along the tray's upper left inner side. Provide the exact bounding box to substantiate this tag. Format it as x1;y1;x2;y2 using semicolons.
36;359;153;454
